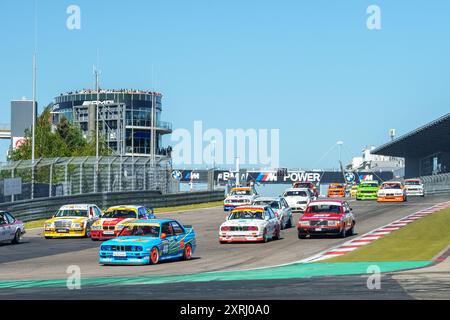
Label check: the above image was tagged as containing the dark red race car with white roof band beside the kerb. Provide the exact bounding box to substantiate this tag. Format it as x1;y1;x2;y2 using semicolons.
297;200;356;239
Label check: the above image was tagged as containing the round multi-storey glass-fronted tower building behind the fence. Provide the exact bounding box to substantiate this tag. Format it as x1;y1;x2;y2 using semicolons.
53;90;172;155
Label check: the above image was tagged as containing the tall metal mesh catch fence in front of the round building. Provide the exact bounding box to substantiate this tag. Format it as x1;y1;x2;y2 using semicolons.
0;156;172;203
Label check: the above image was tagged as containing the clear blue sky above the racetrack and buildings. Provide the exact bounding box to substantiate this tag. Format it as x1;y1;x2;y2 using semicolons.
0;0;450;167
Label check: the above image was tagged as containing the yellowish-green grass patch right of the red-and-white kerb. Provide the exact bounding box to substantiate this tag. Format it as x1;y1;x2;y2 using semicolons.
326;209;450;263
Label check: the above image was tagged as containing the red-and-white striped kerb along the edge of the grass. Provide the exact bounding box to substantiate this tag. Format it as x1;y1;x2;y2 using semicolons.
300;201;450;263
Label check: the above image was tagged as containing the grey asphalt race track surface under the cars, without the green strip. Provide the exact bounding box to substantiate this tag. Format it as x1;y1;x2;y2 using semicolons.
0;196;448;299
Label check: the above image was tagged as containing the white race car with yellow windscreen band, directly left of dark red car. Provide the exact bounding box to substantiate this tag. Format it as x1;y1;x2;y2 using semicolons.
219;206;281;244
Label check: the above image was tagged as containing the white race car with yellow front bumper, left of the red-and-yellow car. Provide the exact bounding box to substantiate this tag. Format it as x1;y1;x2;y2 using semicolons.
44;204;102;239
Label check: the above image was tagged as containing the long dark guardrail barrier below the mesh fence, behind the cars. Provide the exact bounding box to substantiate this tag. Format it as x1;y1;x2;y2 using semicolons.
0;191;225;222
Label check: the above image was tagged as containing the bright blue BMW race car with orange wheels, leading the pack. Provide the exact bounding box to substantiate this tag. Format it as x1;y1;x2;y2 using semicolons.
100;219;196;265
